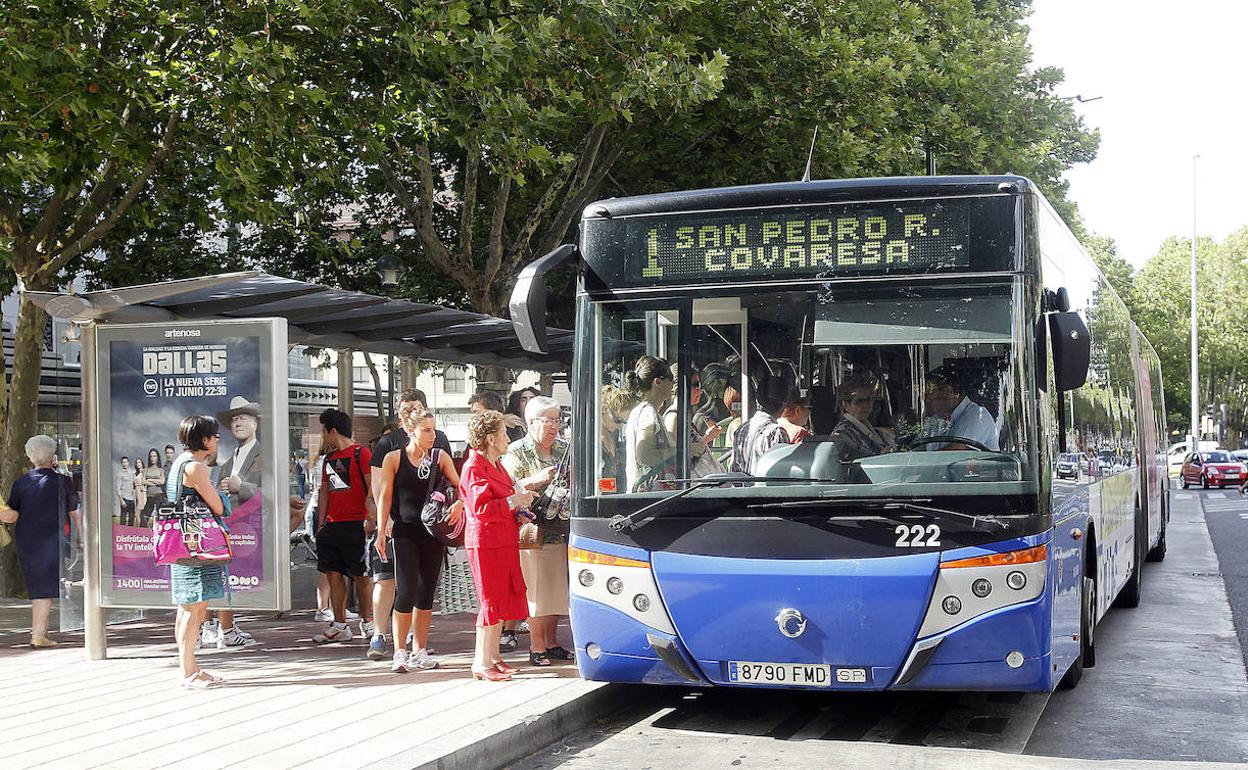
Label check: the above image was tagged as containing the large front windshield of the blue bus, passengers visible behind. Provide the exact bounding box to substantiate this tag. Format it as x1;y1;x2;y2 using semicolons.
577;281;1035;497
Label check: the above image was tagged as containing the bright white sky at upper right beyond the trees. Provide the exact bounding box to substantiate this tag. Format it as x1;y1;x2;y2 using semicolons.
1030;0;1248;267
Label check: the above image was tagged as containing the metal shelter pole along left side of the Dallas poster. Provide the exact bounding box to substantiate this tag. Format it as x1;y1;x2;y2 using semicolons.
80;323;112;660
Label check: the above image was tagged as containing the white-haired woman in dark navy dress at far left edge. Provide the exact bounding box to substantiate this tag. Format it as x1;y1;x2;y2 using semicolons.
0;436;79;648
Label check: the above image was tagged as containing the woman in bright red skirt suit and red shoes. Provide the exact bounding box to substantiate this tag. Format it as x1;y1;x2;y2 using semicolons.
459;412;535;681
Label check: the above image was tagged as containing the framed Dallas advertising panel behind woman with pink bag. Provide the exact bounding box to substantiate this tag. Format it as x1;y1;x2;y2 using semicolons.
97;321;288;609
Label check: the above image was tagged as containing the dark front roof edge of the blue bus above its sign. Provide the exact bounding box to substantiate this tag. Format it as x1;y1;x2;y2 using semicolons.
583;173;1036;218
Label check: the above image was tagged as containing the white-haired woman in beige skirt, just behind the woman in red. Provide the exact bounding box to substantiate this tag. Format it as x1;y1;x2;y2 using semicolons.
503;396;573;665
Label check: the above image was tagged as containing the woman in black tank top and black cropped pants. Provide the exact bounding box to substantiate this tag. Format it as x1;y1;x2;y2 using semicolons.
374;402;463;671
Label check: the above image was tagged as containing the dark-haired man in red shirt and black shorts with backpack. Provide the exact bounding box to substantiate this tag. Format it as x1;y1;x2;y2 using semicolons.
312;409;377;644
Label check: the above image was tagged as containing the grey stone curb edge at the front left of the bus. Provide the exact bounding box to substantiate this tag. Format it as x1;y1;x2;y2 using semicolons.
417;684;644;770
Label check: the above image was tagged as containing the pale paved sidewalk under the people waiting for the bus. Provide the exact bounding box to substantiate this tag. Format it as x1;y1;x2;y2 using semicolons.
0;610;622;770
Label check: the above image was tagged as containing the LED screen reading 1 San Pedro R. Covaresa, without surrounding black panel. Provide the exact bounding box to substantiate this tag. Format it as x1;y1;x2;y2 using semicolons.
624;198;971;285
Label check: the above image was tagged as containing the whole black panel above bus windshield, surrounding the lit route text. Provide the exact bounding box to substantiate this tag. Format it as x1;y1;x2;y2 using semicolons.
584;196;1015;286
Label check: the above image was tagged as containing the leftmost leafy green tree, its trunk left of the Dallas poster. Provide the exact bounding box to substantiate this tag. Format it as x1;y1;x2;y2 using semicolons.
0;0;361;484
